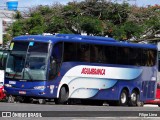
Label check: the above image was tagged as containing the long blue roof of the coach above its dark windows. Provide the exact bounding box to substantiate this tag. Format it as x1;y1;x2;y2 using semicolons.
13;34;157;49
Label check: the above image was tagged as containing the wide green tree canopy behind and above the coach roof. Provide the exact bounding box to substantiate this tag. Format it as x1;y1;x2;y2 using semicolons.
5;0;160;40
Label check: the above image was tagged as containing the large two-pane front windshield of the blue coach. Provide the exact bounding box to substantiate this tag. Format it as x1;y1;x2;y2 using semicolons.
6;42;48;80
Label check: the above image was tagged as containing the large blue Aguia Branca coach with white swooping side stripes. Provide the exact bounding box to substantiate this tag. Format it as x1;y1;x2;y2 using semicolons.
4;34;157;106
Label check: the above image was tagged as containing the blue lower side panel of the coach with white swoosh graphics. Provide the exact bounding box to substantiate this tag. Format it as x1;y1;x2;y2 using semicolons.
57;62;156;101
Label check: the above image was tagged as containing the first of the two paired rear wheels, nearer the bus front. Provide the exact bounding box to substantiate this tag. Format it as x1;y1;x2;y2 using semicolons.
118;89;128;106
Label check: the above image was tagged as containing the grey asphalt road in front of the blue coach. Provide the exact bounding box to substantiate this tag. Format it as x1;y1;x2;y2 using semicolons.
0;102;160;120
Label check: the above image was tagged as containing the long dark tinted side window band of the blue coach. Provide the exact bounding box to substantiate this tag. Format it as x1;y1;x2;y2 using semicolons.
64;42;156;66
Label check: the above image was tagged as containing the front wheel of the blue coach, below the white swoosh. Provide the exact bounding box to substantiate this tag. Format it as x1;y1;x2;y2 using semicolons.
54;86;69;104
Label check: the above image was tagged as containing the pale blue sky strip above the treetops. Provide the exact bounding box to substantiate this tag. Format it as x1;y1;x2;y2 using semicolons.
0;0;160;9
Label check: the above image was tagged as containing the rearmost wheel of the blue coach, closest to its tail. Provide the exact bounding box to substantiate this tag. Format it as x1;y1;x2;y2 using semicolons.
129;90;139;106
